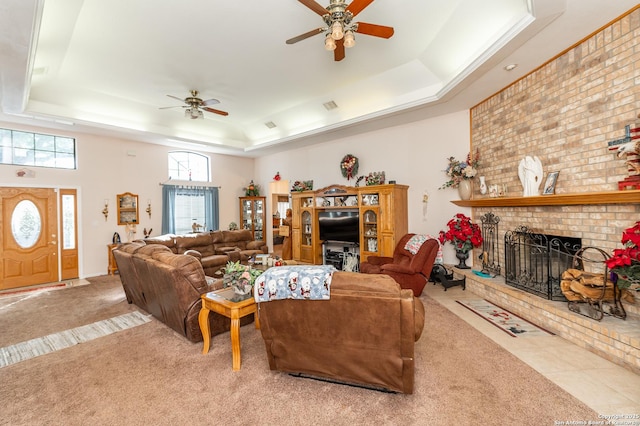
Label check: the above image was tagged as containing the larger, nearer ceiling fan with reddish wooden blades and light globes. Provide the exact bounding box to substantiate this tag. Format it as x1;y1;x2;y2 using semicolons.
286;0;393;61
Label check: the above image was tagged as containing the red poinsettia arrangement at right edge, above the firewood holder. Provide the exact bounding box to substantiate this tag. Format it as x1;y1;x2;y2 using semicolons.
605;221;640;288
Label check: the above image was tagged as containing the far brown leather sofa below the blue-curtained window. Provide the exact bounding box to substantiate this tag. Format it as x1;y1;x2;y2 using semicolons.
139;229;269;276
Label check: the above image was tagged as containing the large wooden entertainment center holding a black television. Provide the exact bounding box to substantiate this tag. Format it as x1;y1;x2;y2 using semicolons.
291;184;409;269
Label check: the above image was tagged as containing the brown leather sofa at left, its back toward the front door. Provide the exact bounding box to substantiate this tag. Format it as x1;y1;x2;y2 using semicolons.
113;242;253;342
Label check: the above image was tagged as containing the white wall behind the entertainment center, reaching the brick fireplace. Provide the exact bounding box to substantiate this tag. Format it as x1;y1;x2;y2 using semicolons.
255;111;471;263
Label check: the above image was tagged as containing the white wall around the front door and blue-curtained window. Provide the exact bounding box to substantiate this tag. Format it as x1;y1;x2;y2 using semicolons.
0;122;254;277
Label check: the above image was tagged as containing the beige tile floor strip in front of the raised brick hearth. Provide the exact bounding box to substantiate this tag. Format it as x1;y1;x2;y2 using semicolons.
423;283;640;418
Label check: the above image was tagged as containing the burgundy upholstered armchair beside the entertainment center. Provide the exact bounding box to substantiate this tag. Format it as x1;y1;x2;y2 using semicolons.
360;234;440;297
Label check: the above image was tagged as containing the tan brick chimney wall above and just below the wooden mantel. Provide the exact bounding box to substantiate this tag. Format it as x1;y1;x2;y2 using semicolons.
471;6;640;255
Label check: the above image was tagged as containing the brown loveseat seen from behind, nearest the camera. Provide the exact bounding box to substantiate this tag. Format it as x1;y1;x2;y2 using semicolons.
258;271;424;394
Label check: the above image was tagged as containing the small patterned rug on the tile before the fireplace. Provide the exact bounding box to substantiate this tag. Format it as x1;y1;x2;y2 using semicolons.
456;299;553;337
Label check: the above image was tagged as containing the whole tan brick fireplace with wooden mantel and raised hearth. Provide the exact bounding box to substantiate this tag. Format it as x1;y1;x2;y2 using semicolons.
456;6;640;374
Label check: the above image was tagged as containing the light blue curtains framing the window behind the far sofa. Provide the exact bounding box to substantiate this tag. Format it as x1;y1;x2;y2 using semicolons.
162;185;220;234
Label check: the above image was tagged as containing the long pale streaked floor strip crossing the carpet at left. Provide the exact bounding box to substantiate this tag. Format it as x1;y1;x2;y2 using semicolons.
0;311;151;368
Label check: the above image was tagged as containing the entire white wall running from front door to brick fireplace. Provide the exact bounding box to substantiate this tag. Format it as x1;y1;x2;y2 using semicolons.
0;111;471;277
